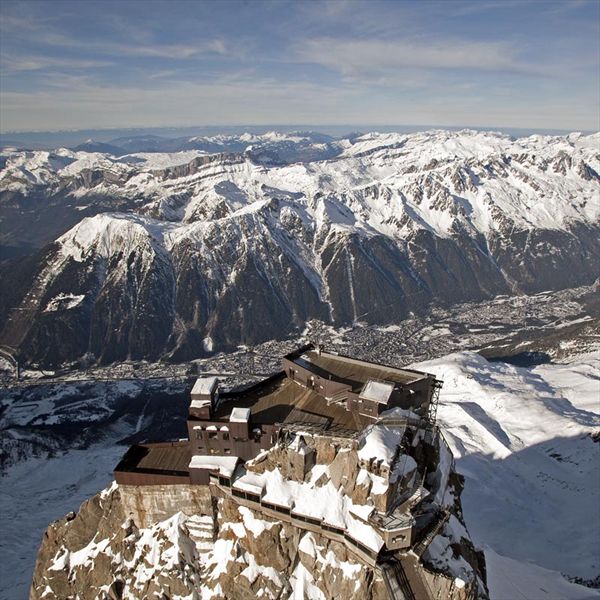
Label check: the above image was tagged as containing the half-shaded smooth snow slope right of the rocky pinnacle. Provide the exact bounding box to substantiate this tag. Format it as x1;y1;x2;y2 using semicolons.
414;352;600;600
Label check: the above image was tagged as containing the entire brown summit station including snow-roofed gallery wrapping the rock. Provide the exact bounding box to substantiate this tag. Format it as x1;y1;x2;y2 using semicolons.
115;345;441;564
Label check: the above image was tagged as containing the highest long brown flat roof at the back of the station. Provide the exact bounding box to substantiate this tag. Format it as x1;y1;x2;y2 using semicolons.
291;350;430;391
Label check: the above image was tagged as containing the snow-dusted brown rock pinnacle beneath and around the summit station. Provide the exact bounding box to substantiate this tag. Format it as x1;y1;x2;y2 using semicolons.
30;426;487;600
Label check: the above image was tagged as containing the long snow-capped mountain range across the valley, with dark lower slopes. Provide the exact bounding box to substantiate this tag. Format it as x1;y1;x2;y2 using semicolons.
0;131;600;363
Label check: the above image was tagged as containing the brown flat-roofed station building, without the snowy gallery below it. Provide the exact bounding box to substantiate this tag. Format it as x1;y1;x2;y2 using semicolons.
115;344;440;485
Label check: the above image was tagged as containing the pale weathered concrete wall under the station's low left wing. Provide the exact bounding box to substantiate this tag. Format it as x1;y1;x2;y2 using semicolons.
119;485;213;527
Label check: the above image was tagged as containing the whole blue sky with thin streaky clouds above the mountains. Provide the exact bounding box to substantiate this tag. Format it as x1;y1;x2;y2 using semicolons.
0;0;600;132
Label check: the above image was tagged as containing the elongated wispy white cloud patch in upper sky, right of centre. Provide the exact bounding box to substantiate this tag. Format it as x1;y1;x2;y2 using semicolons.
296;38;537;78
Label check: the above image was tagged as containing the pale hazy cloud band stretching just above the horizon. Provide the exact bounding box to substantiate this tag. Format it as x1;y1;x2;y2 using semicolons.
0;77;598;131
